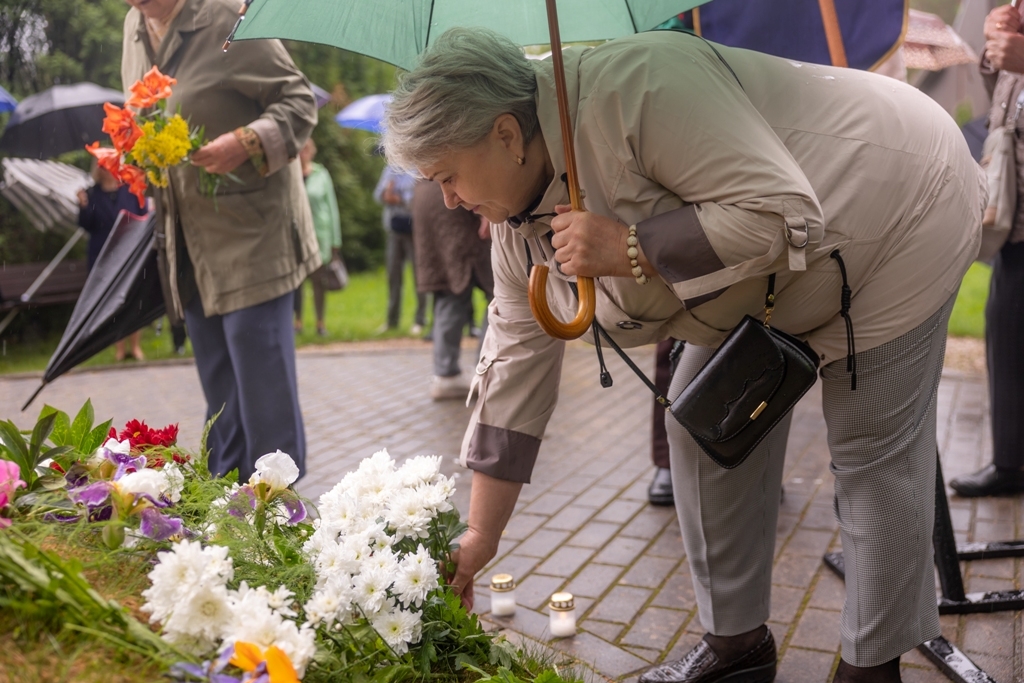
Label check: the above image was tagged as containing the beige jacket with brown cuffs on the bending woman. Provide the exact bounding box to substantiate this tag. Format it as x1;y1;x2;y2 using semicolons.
462;32;985;481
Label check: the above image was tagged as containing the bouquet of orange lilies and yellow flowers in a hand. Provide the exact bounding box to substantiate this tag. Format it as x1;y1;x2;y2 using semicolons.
85;67;220;204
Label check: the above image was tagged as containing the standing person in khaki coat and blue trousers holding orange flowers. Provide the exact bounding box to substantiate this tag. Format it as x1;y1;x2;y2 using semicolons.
121;0;321;479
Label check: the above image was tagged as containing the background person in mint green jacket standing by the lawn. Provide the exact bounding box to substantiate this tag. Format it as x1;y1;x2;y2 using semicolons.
295;138;341;337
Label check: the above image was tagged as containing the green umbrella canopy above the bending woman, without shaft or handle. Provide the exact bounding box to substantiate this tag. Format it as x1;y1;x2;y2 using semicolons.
234;0;701;70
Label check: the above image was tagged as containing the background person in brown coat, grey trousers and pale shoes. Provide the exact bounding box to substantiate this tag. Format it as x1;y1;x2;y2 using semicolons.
413;180;495;400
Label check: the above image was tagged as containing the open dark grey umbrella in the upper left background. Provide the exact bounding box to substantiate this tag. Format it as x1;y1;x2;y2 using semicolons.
0;83;125;159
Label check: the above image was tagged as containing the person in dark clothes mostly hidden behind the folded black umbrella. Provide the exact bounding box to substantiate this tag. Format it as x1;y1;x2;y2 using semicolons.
78;162;146;361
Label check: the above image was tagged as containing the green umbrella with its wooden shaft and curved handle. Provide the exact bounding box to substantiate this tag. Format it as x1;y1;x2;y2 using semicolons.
231;0;707;339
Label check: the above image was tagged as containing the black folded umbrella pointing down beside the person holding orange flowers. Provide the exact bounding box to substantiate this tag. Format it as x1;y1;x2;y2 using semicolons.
22;211;165;411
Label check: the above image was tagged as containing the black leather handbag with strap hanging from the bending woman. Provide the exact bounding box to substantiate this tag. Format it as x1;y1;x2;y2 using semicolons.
595;268;823;469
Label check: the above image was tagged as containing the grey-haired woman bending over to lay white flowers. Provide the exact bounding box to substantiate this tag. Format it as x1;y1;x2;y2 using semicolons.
384;30;984;683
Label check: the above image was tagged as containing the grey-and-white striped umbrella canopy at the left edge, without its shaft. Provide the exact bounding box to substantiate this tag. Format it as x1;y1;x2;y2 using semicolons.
0;158;92;232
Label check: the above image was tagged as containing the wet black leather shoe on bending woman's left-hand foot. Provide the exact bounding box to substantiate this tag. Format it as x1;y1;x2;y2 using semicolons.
639;629;778;683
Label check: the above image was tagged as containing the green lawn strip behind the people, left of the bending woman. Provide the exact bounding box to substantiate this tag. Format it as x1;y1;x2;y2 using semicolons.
0;268;486;375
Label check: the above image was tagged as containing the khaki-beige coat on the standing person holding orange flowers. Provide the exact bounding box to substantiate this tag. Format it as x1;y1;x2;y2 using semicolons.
121;0;321;315
